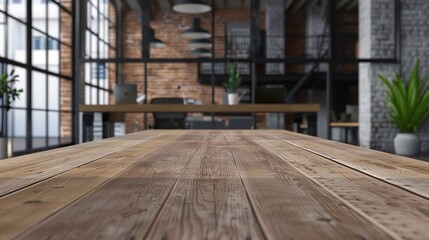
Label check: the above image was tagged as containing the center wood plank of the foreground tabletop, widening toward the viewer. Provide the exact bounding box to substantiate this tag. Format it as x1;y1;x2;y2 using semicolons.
148;132;264;239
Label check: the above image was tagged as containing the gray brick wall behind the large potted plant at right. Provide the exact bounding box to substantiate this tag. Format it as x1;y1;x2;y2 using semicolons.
359;0;429;152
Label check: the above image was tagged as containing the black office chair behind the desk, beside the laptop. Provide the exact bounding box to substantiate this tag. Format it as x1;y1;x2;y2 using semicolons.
150;98;187;129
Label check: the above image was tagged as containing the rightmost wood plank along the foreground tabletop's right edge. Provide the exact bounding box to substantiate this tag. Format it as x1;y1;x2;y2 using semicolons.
273;131;429;199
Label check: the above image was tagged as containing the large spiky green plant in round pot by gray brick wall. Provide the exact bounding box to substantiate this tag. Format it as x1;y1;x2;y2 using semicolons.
379;61;429;156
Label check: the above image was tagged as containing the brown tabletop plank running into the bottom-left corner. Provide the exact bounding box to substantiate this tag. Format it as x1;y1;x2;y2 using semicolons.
0;135;177;239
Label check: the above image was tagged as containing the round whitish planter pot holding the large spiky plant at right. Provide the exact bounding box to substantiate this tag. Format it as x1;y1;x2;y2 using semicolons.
394;133;420;156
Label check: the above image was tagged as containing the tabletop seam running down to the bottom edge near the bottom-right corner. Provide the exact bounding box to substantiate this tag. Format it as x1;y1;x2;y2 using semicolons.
254;137;402;240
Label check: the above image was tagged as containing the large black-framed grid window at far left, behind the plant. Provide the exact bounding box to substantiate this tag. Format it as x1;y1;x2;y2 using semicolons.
0;0;73;153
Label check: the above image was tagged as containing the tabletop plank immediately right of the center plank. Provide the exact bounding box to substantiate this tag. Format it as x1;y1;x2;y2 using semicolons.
222;136;392;239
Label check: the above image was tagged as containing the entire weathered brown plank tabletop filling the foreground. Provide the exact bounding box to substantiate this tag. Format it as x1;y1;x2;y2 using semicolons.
0;130;429;240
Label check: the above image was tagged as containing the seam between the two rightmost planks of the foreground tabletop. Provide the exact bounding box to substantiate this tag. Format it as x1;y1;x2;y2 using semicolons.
262;131;429;200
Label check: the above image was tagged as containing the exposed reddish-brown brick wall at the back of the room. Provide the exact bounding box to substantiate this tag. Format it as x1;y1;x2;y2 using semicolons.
122;9;264;132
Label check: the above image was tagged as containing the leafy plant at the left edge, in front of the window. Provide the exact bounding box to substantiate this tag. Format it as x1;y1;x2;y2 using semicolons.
0;70;23;159
